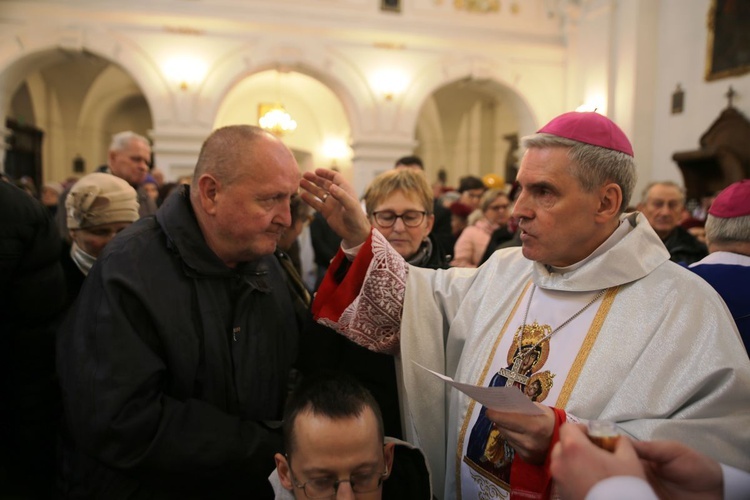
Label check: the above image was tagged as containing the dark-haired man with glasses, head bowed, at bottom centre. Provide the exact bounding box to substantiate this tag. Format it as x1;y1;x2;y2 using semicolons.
269;372;431;499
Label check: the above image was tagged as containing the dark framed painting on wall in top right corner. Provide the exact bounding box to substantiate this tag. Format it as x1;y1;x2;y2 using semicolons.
706;0;750;81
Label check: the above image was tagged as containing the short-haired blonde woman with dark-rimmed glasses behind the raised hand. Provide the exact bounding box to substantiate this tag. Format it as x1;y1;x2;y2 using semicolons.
364;169;449;269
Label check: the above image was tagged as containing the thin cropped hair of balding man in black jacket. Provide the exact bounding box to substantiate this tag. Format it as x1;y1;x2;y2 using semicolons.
190;125;269;193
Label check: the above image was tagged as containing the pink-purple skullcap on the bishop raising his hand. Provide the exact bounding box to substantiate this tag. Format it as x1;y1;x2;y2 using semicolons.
537;111;633;156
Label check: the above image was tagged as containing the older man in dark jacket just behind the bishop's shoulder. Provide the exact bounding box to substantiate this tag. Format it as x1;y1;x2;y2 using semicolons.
638;181;708;265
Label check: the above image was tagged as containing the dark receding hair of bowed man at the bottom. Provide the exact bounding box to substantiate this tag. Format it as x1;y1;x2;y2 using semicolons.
282;371;384;460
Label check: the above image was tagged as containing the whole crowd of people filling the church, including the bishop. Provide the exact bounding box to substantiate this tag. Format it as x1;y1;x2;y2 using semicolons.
0;112;750;499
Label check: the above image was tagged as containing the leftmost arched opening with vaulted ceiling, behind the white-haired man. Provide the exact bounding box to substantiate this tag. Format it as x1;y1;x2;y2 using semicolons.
6;48;153;187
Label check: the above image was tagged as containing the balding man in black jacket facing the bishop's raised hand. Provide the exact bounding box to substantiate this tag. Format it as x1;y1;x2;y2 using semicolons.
57;126;299;499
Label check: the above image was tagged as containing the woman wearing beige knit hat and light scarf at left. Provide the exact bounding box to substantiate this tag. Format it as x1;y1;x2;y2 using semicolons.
62;173;138;302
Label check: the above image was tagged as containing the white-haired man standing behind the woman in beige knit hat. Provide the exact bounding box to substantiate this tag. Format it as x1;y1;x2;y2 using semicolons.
56;130;156;240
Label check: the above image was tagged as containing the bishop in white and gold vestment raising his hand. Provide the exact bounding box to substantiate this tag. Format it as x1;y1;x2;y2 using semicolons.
301;112;750;499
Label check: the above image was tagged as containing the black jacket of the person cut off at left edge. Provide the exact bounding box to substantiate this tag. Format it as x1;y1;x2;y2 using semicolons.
0;180;65;498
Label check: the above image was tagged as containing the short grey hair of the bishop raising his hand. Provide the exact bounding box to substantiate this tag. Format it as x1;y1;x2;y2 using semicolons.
521;134;637;213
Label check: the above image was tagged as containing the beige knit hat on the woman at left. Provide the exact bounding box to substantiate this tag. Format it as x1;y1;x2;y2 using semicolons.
65;173;138;229
